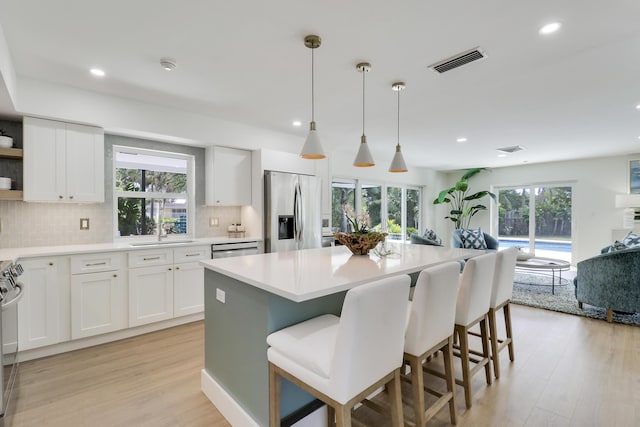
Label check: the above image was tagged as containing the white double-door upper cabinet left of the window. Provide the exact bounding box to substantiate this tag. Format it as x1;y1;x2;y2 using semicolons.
23;117;104;202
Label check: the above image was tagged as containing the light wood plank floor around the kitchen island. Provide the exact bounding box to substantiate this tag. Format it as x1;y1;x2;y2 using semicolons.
8;305;640;427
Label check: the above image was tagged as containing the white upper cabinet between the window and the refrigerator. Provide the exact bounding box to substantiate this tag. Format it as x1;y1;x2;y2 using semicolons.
206;147;251;206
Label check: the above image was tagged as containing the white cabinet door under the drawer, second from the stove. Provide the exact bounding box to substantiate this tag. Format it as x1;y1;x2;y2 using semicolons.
71;271;127;339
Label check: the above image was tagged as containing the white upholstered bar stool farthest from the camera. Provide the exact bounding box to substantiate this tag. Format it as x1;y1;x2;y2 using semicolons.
489;248;518;378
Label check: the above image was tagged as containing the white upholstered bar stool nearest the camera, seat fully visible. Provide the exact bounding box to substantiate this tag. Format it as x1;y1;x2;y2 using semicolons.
267;275;411;427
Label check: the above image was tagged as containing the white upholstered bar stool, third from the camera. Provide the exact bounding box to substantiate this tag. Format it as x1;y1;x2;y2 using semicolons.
455;253;496;409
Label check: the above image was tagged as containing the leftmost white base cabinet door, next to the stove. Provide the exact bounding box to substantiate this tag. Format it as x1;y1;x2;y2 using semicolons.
18;258;62;350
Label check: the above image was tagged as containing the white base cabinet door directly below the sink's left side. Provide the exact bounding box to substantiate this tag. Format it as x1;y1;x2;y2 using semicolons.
129;265;173;327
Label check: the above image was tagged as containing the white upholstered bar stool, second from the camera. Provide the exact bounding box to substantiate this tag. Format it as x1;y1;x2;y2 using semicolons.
403;262;460;427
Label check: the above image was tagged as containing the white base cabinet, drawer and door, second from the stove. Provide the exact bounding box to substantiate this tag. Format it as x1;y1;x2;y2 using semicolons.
71;252;128;339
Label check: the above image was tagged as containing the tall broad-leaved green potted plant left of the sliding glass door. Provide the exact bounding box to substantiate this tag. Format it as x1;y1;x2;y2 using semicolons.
433;168;497;229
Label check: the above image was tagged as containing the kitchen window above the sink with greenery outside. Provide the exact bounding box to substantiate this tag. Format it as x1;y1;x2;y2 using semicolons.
113;146;194;237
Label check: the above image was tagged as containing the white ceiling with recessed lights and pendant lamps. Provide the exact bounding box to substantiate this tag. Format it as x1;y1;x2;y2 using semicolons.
0;0;640;169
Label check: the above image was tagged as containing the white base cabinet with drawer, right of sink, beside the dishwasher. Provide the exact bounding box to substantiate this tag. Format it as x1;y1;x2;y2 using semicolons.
173;246;211;317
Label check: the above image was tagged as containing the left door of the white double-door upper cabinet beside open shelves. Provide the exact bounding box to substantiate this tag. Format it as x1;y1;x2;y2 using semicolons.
23;117;67;201
